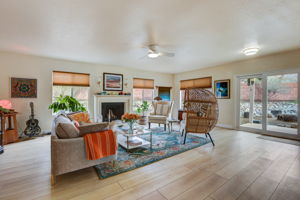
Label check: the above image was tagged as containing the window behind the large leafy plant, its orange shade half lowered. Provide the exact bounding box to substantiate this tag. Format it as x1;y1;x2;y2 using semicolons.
52;71;90;111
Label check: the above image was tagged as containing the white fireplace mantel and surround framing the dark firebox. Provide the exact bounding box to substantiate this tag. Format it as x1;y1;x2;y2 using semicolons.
94;95;132;121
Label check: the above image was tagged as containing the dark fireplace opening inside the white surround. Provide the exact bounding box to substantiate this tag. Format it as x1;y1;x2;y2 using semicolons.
101;102;124;122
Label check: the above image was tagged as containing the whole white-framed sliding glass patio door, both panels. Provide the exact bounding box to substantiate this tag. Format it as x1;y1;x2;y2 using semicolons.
237;71;300;138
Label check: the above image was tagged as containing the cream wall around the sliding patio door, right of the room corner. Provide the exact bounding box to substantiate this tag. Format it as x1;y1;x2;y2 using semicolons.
173;50;300;128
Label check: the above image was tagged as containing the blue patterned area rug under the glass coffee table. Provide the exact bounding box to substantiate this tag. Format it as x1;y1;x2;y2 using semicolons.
95;128;210;178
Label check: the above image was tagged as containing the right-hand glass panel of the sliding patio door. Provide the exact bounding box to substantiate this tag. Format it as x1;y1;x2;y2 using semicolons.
267;73;298;135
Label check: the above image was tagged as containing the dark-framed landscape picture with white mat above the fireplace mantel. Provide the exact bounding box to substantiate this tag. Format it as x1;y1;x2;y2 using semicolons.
103;73;123;91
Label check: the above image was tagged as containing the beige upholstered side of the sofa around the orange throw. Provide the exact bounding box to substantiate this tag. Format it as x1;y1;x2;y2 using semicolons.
51;113;116;185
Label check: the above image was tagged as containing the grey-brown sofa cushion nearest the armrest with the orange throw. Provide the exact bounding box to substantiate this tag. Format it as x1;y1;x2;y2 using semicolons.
56;123;79;139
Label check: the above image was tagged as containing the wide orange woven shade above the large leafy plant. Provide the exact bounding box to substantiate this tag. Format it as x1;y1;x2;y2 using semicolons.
52;71;90;87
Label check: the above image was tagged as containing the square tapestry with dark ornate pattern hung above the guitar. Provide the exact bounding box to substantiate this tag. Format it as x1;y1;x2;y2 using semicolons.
11;78;37;98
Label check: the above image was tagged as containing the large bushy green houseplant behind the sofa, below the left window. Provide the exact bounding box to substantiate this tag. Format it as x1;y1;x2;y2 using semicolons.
49;95;86;113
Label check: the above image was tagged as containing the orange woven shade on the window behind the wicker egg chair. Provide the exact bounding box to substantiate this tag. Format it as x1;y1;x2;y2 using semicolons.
180;77;212;90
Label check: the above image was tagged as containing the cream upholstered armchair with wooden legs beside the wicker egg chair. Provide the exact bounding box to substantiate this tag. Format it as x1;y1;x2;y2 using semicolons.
148;101;174;131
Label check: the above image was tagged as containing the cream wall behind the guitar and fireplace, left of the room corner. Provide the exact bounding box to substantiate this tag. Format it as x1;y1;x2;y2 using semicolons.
0;52;173;132
